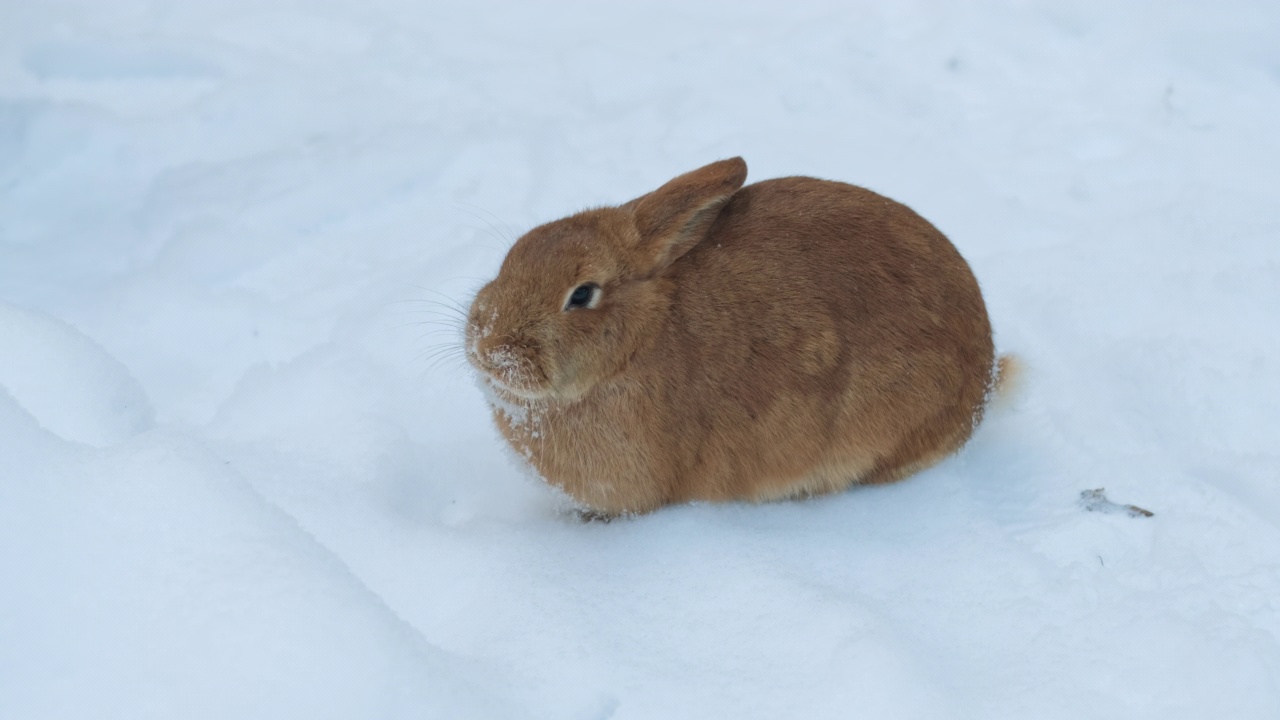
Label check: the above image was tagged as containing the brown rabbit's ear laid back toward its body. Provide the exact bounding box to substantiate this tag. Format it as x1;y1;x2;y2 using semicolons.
622;158;746;274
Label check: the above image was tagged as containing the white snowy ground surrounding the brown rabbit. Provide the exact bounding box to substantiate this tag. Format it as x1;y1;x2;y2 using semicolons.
0;0;1280;720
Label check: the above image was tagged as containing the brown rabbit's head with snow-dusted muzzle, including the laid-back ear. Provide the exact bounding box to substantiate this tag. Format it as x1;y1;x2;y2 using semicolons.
466;158;746;402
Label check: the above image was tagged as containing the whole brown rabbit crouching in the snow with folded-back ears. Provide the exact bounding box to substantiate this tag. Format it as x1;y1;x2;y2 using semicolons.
466;158;1005;516
